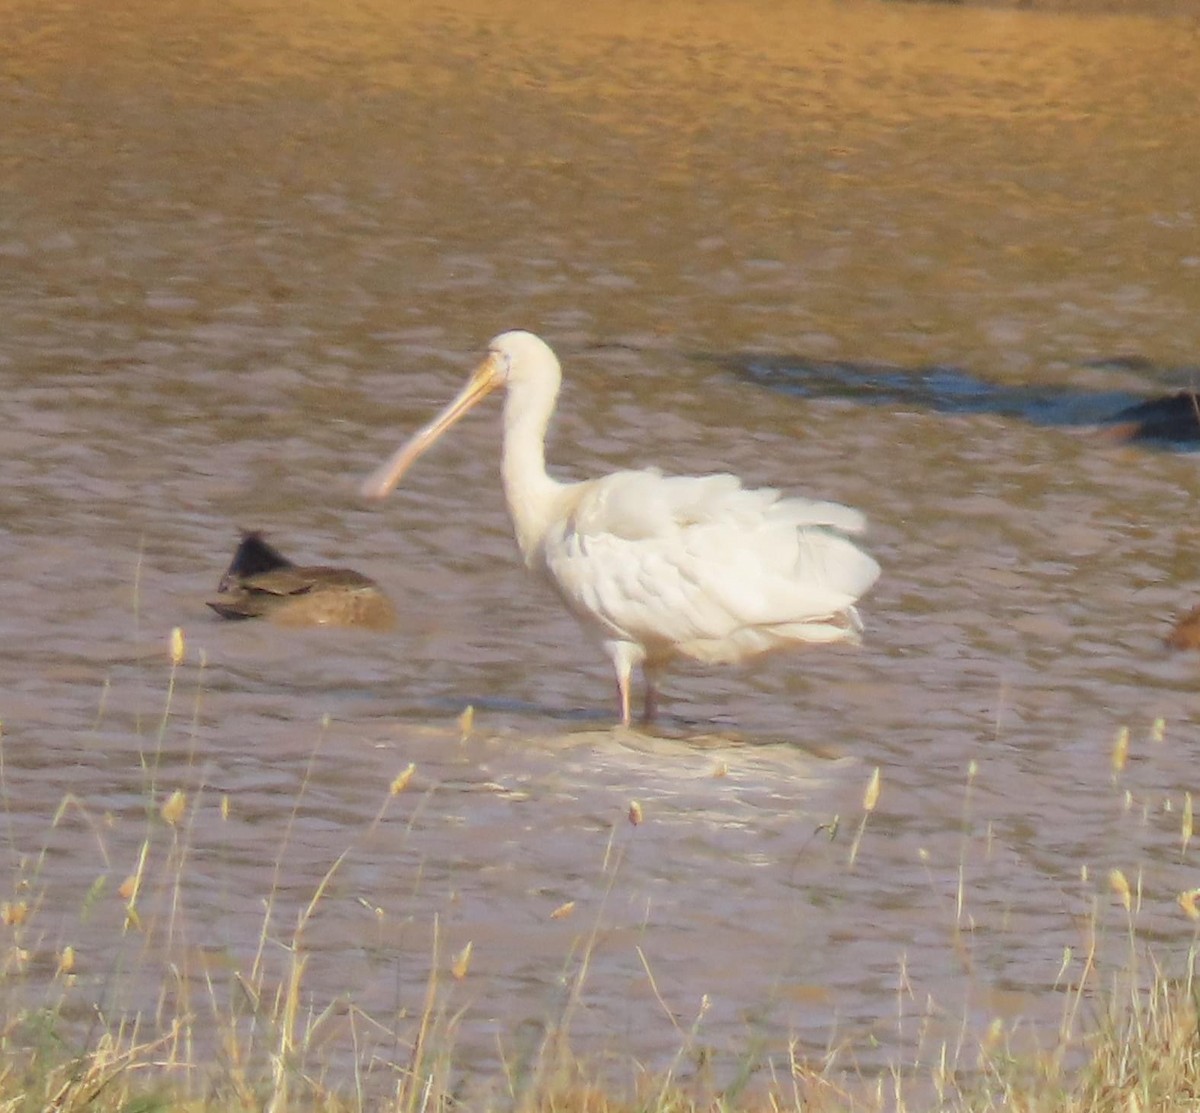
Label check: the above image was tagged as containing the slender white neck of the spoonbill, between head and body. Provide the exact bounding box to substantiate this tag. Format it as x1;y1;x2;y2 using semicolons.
500;381;570;566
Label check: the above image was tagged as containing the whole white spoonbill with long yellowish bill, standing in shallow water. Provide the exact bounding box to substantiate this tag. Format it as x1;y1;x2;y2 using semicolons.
362;332;880;726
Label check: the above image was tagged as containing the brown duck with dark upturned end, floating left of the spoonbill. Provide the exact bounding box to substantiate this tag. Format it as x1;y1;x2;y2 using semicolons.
209;533;396;630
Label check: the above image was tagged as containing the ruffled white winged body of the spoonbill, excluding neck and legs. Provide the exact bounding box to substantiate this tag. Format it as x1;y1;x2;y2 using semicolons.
544;471;880;662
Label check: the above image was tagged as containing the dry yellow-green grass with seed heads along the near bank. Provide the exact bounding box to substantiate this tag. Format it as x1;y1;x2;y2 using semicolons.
0;631;1200;1113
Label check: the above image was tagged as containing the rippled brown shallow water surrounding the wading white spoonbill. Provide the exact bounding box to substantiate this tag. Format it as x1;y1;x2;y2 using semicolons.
0;0;1200;1093
